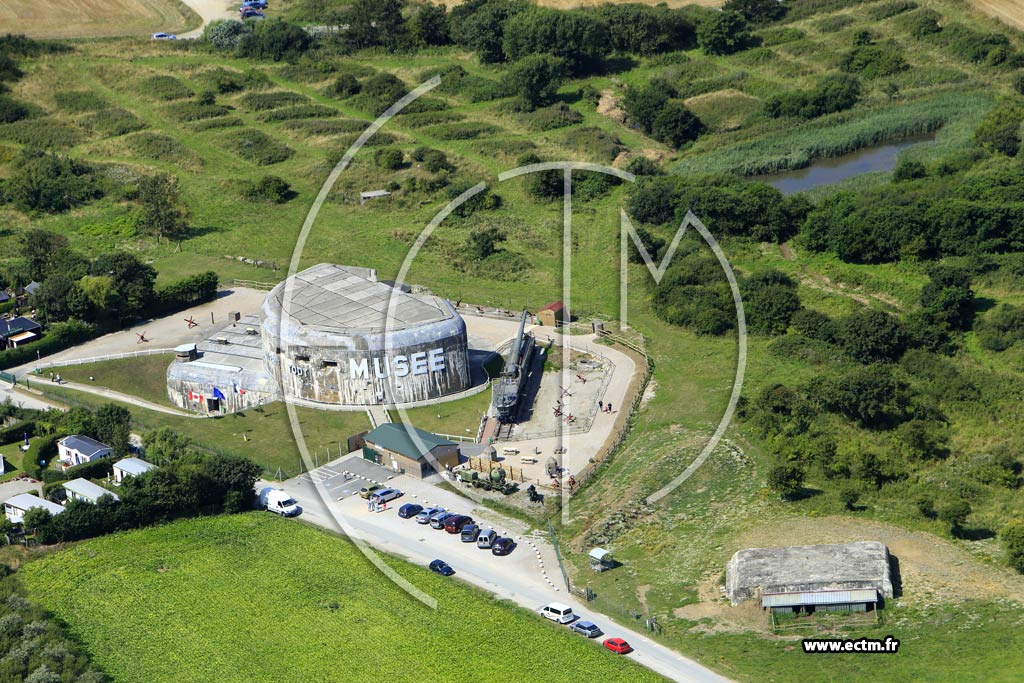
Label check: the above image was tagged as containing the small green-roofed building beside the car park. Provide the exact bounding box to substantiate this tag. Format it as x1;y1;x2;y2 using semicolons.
362;423;459;479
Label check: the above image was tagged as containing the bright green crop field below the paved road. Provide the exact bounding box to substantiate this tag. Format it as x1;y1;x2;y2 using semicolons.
19;513;663;683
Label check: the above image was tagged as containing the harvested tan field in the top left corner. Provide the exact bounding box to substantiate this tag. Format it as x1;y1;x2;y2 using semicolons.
0;0;200;38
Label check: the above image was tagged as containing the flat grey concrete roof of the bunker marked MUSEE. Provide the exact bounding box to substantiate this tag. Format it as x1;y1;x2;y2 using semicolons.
263;263;456;333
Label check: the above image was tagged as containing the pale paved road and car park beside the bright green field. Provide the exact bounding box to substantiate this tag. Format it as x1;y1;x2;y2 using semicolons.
273;459;728;683
